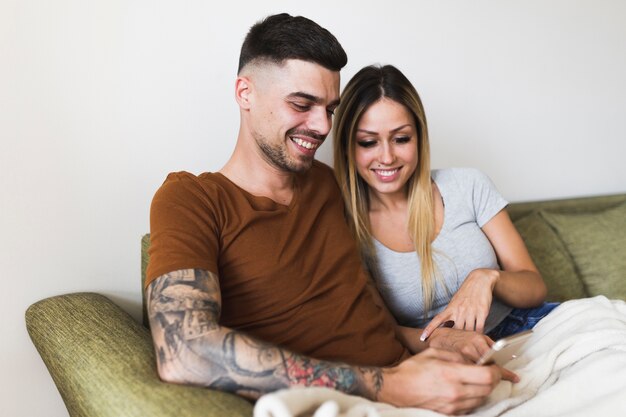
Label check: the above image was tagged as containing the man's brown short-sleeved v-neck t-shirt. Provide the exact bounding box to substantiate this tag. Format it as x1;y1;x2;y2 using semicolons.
146;161;407;366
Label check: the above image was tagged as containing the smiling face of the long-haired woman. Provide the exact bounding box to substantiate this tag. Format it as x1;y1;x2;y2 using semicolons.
355;98;418;195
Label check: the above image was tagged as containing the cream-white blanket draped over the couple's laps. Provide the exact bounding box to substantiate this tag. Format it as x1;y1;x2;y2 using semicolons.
254;296;626;417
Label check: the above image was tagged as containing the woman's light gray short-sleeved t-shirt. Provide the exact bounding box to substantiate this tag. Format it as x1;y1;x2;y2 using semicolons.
373;168;512;333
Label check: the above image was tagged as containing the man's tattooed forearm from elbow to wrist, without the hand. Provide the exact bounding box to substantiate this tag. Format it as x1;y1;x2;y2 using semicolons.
155;329;382;398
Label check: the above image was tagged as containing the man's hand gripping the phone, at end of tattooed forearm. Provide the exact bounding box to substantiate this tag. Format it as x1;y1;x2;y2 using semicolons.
377;348;517;414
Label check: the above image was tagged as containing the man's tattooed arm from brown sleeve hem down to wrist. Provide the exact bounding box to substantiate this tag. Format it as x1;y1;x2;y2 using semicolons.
146;269;383;400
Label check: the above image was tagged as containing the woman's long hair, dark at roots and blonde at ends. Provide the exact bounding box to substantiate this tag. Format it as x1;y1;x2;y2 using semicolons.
333;65;437;312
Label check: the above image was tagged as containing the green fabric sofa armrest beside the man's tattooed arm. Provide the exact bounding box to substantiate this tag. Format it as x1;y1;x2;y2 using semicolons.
26;293;253;417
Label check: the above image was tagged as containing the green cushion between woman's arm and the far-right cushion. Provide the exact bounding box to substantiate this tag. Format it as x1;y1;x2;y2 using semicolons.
515;211;587;301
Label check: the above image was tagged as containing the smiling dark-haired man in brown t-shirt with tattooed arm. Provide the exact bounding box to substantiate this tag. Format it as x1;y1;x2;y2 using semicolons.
146;14;513;413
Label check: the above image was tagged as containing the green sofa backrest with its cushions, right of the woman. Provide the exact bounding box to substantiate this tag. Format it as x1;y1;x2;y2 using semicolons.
507;194;626;301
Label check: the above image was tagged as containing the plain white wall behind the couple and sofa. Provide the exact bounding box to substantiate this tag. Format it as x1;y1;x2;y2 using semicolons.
0;0;626;417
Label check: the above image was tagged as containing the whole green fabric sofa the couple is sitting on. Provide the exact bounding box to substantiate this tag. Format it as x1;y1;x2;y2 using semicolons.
26;194;626;417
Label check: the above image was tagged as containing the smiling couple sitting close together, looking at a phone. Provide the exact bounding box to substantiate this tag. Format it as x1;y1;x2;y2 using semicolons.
145;14;555;413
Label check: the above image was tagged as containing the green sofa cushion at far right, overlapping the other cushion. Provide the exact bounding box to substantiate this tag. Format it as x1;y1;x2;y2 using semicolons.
541;204;626;299
